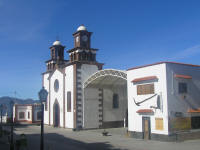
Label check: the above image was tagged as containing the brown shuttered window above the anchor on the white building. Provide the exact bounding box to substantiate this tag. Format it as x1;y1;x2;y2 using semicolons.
137;84;155;95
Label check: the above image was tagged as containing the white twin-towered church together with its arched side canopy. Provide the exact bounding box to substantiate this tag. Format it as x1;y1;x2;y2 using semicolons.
42;25;127;129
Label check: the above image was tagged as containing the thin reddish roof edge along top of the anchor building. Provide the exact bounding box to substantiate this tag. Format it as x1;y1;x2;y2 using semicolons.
127;61;200;71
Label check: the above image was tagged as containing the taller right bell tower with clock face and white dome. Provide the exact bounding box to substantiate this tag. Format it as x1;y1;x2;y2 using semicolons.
68;25;97;62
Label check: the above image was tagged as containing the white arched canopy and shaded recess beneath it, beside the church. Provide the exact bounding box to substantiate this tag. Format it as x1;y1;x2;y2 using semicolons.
83;69;128;128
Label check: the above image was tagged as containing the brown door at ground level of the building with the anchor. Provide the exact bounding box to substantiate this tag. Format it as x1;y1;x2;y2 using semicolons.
143;117;151;140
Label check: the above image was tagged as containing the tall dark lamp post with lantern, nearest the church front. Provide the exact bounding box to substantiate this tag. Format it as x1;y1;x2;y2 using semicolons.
38;87;48;150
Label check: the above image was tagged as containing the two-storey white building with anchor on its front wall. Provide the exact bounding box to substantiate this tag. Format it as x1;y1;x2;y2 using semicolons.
127;62;200;140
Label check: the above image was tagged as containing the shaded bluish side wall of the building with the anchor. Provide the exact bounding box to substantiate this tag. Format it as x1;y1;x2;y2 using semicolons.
167;64;200;118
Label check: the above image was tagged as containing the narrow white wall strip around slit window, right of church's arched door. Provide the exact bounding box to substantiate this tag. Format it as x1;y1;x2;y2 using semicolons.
65;65;74;128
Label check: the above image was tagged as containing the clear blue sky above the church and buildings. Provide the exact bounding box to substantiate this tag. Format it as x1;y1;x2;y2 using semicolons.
0;0;200;99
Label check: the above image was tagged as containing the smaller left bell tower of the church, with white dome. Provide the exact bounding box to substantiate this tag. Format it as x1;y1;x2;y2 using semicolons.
46;40;65;71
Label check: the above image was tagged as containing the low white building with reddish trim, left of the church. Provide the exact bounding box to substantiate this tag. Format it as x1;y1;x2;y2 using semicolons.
13;103;41;123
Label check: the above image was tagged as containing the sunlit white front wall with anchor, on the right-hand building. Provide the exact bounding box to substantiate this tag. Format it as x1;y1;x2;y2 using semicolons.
127;64;168;134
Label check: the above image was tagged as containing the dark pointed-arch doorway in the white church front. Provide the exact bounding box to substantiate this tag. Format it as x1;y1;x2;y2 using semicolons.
53;99;60;127
